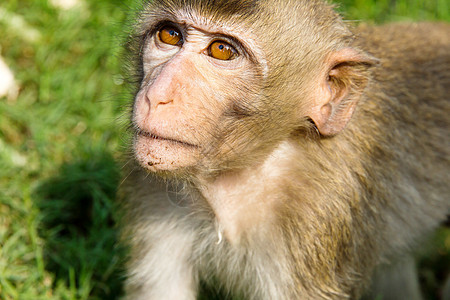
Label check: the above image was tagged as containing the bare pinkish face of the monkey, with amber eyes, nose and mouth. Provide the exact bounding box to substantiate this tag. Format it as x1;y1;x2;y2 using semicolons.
133;19;263;175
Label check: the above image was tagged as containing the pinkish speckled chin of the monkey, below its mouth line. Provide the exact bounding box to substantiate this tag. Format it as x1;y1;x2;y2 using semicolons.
134;134;200;172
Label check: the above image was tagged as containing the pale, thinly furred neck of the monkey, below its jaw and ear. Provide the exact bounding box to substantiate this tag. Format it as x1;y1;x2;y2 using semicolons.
201;142;296;244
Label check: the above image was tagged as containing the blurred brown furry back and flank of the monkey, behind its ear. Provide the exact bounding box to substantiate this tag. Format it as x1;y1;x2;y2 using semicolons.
349;23;450;251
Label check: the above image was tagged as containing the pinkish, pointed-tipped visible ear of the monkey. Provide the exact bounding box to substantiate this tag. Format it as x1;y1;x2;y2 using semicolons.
308;48;378;136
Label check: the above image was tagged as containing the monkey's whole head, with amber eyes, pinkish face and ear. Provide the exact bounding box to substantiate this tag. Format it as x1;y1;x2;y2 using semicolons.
127;0;373;178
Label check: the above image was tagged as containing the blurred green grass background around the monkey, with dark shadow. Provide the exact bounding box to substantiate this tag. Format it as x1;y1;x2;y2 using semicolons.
0;0;450;300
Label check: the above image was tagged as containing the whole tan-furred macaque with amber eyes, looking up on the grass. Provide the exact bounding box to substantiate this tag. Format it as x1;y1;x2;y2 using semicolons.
121;0;450;300
